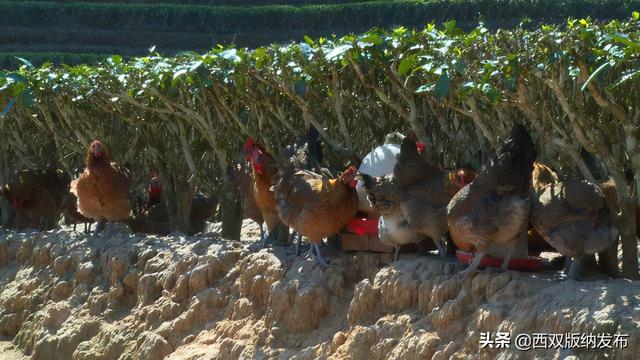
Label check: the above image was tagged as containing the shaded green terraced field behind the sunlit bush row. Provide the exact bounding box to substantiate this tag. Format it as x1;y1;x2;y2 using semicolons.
0;0;640;68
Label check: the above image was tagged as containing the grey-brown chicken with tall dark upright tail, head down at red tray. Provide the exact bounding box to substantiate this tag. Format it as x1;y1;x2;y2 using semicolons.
447;124;537;274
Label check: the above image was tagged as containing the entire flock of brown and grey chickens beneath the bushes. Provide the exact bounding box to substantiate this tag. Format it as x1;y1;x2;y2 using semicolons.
2;124;632;278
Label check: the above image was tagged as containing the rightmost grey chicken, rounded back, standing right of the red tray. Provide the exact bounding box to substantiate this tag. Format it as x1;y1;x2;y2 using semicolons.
531;180;618;279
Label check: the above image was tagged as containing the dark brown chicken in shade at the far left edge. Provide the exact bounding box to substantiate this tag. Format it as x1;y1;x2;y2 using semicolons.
2;167;71;230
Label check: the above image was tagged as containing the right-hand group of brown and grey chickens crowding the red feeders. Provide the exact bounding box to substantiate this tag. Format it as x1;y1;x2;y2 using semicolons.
244;124;618;279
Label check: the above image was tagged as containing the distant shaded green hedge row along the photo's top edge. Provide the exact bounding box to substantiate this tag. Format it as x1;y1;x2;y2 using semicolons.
0;0;640;33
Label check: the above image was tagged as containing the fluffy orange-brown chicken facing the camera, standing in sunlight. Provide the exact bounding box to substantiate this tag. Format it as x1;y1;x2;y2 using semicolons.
71;140;131;233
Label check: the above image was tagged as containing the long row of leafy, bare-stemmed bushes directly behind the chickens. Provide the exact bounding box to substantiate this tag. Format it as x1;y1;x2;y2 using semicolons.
0;12;640;278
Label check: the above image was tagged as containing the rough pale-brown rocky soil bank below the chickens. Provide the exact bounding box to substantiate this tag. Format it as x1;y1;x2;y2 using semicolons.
0;219;640;360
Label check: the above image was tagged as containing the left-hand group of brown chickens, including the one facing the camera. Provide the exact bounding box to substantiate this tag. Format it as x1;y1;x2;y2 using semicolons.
2;140;217;235
